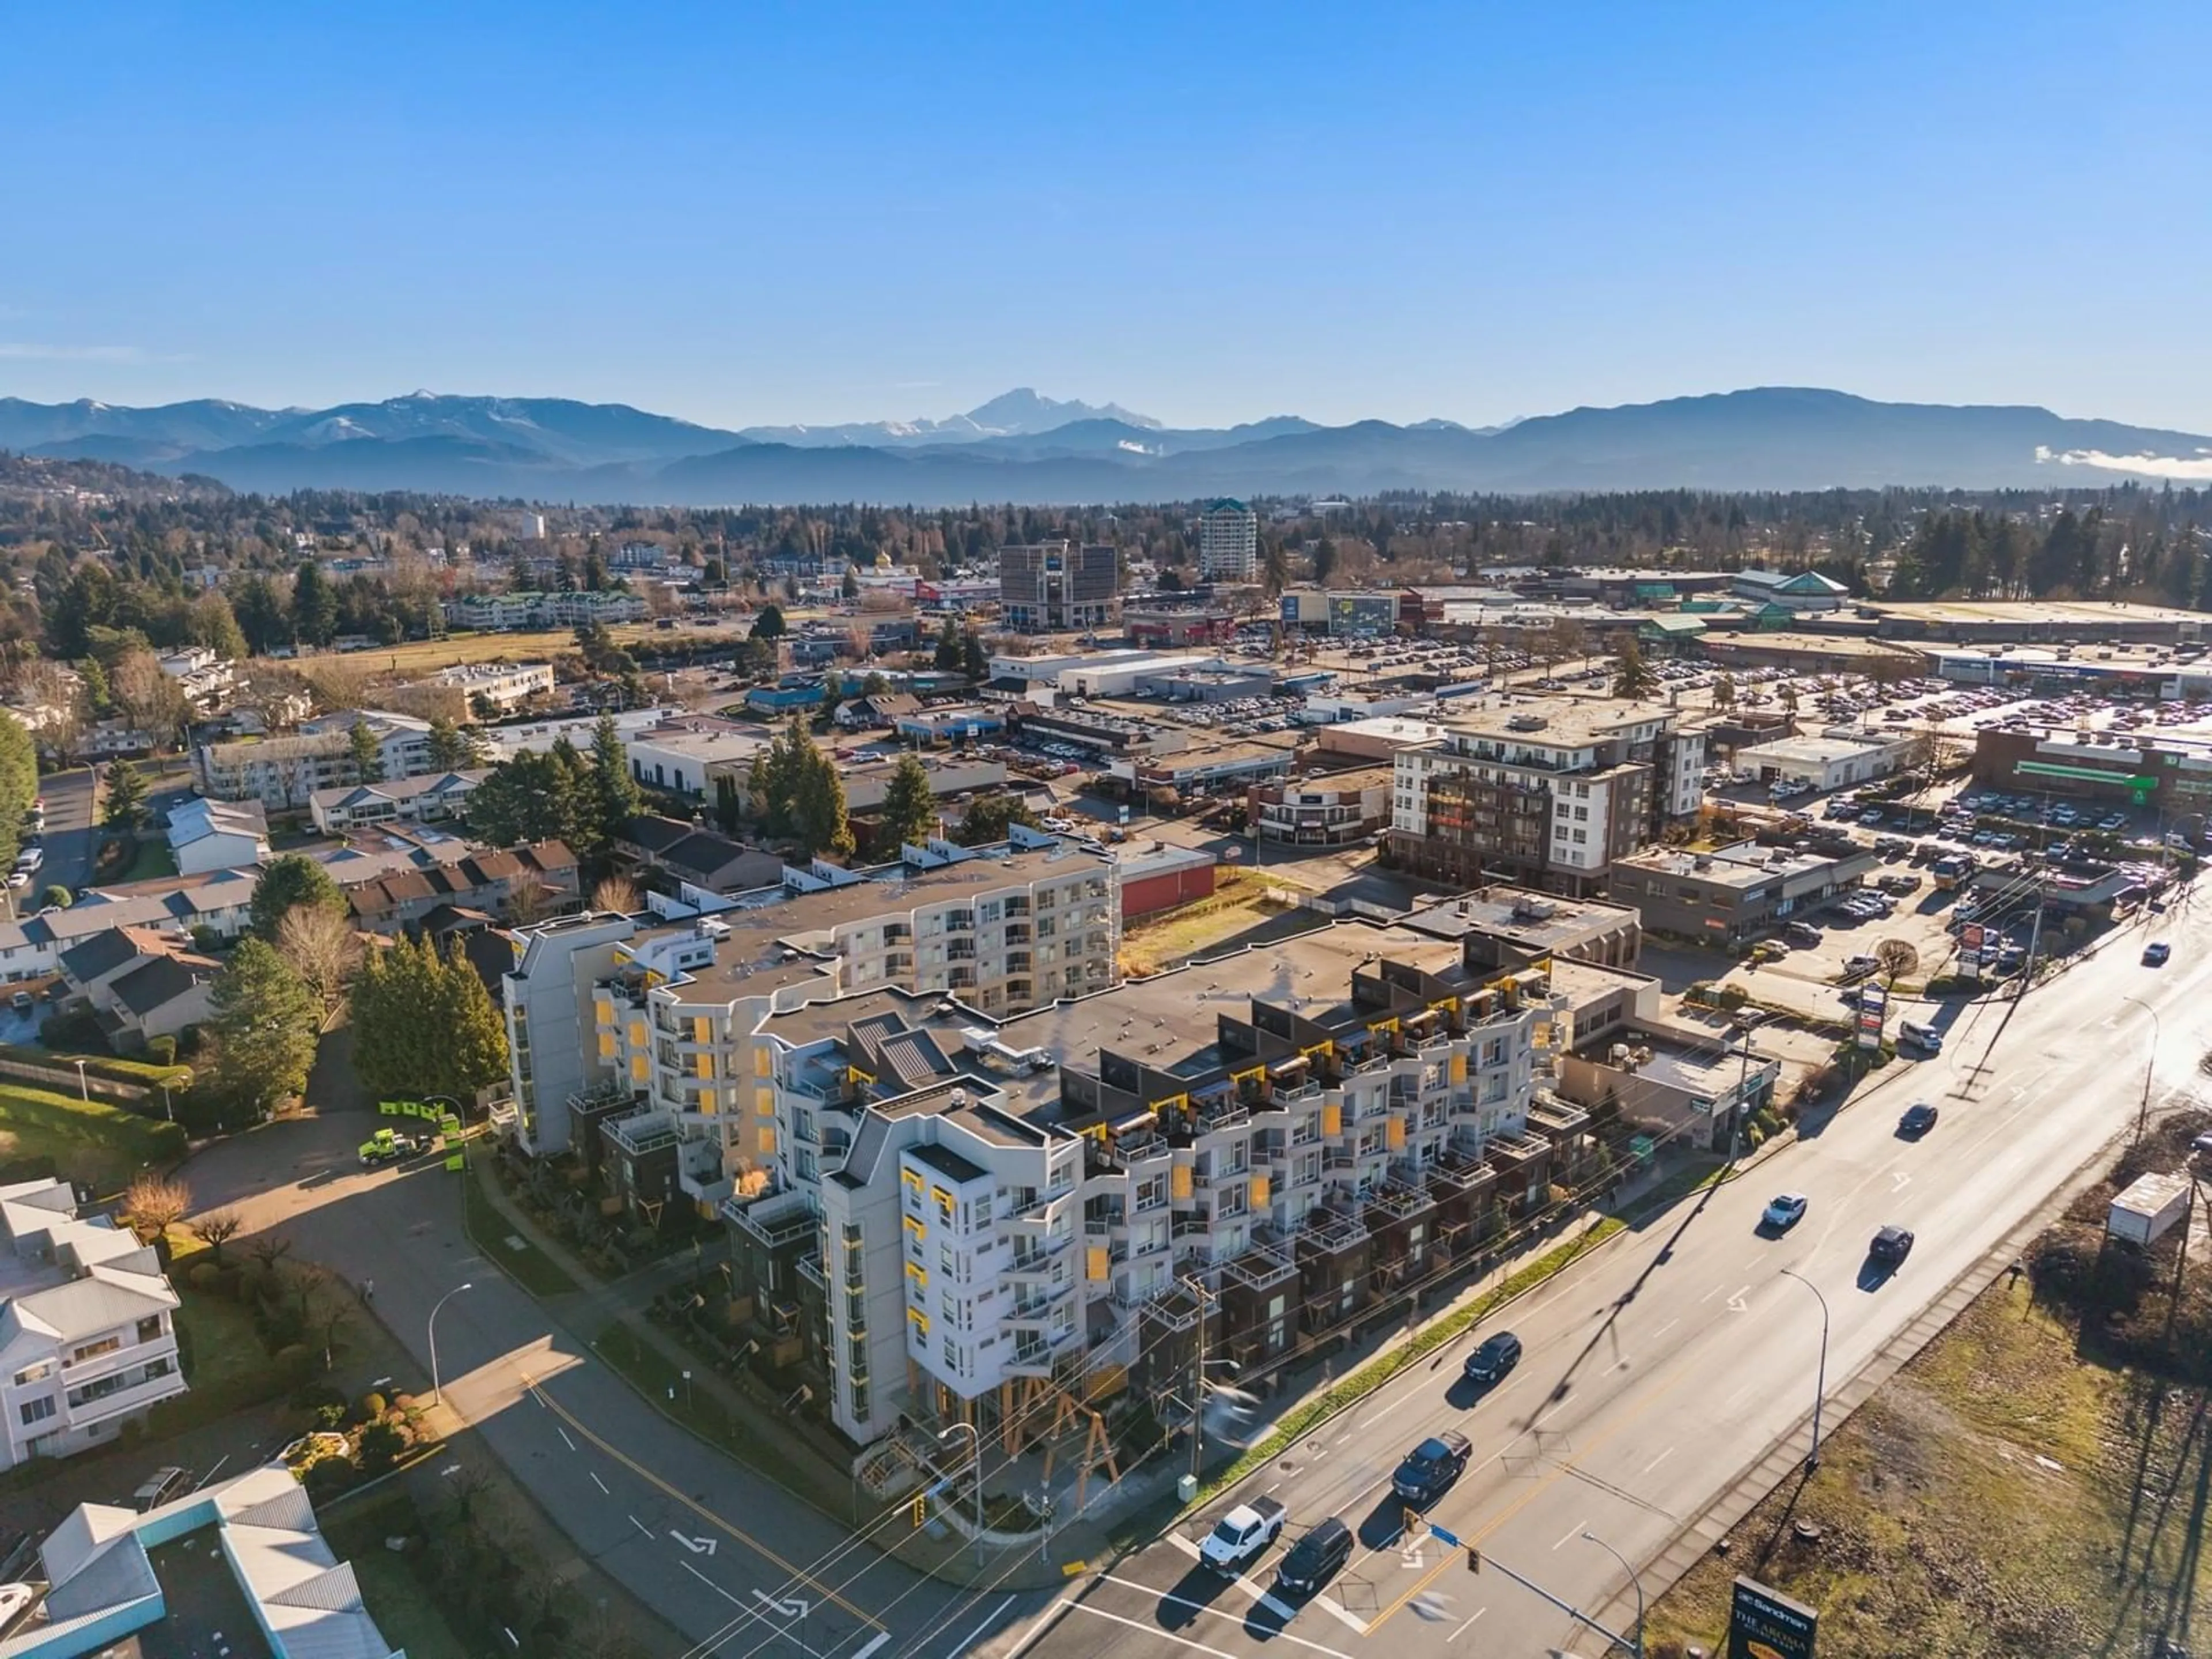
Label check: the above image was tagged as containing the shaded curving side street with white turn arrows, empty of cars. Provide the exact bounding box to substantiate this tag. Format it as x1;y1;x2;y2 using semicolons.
186;1113;1013;1659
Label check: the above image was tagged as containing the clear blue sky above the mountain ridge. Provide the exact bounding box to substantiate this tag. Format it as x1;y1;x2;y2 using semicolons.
0;0;2212;431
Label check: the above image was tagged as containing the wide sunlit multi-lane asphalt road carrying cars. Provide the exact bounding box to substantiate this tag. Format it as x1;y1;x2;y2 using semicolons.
1029;909;2212;1659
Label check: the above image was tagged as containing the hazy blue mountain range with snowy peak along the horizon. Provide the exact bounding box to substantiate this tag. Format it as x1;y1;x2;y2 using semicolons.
0;387;2212;506
